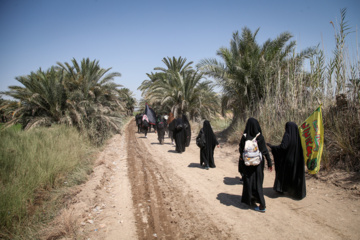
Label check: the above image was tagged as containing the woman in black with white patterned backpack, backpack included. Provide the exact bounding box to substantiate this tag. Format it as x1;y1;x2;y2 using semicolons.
239;118;272;212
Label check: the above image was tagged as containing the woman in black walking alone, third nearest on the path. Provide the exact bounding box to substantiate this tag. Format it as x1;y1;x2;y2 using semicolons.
200;120;219;170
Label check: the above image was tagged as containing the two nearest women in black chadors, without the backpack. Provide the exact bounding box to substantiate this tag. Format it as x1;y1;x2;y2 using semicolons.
238;118;306;212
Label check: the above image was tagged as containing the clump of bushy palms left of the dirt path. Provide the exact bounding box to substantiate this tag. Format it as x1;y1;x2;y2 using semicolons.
2;59;124;142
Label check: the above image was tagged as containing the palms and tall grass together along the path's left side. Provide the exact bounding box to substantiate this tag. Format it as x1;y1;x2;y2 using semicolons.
0;59;136;239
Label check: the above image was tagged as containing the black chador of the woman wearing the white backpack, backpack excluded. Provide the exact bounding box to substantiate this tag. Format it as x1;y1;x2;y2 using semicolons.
239;118;272;212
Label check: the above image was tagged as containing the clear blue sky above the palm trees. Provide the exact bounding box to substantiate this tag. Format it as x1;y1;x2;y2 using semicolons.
0;0;360;99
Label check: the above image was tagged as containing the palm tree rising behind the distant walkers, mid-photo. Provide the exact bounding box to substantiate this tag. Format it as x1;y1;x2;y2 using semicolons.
138;57;217;117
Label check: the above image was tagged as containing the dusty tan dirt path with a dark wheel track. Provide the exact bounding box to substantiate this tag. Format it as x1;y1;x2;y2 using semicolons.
57;121;360;239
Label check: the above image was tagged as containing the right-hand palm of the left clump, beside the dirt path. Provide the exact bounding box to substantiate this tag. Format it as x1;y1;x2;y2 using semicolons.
58;58;124;143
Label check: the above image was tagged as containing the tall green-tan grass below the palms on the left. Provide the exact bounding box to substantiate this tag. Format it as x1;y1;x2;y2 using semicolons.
0;125;94;238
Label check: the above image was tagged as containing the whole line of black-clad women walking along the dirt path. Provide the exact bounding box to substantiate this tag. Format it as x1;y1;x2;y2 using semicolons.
135;113;306;212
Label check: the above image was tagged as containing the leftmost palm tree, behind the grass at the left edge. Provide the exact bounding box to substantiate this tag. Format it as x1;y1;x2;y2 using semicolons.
4;67;66;129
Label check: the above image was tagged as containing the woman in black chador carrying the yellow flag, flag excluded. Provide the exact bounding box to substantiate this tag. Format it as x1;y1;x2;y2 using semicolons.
268;122;306;199
